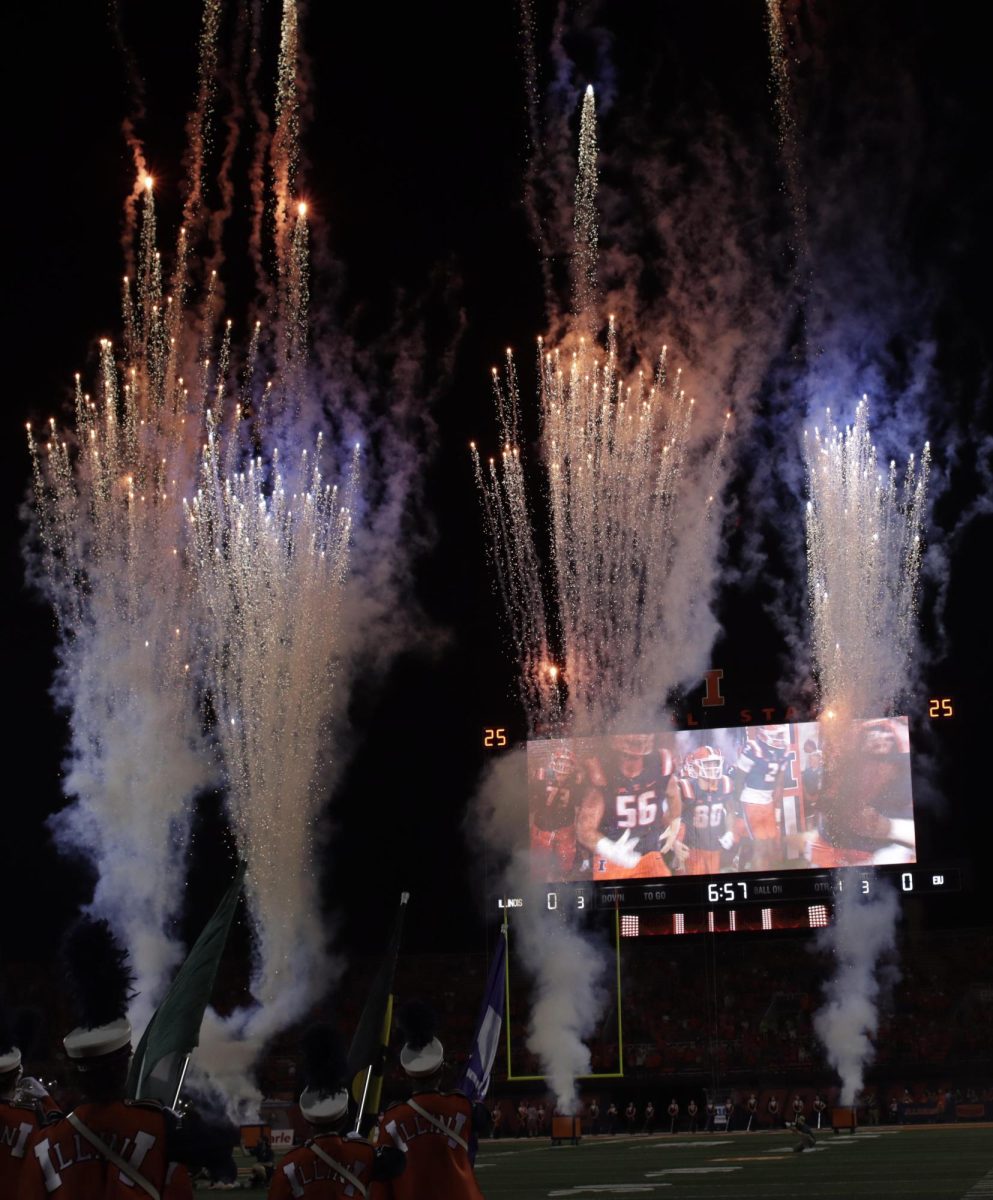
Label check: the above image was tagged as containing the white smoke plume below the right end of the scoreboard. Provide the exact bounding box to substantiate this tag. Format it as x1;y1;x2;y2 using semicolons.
813;881;899;1105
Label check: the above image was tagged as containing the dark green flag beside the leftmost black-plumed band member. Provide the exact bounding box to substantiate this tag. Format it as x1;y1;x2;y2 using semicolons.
127;863;246;1106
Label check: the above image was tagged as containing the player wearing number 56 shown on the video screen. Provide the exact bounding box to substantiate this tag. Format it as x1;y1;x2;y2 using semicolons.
577;733;681;880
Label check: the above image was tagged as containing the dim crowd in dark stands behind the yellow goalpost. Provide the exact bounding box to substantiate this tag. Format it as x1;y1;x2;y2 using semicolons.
7;930;993;1135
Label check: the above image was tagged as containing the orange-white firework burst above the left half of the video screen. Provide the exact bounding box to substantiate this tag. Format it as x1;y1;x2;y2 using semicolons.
471;89;729;731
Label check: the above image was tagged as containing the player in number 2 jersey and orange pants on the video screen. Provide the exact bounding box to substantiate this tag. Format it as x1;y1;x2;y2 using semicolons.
735;725;793;871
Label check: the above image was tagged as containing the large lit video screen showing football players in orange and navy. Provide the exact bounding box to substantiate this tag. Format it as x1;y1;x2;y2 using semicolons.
528;716;917;883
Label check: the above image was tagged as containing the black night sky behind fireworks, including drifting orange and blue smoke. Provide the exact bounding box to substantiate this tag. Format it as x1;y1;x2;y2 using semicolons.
0;0;993;974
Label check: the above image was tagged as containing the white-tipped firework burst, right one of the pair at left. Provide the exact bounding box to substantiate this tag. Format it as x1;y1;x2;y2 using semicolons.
188;420;357;1056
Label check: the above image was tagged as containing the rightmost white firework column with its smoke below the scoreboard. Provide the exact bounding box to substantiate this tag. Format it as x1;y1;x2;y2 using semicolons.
806;397;929;1104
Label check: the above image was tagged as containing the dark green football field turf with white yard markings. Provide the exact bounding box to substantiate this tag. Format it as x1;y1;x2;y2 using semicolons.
467;1126;993;1200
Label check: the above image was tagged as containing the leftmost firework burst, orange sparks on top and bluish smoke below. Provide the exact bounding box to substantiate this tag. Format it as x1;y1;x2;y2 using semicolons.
29;182;213;1026
